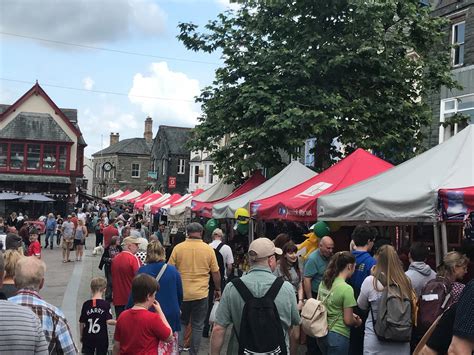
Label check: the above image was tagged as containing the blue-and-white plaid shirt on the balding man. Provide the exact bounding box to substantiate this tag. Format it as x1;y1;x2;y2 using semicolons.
8;289;77;355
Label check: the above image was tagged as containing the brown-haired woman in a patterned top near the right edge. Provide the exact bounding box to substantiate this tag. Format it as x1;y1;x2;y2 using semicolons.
436;251;469;303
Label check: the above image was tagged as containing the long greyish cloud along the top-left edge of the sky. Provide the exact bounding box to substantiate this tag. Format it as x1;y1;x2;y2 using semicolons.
0;0;166;48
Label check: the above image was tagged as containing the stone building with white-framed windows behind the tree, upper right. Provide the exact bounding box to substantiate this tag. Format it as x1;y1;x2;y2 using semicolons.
427;0;474;147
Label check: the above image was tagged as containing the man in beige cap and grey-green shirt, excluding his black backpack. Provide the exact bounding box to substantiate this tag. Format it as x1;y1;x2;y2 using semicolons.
211;238;301;354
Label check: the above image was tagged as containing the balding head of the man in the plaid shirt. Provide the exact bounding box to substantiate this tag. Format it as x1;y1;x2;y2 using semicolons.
14;256;46;291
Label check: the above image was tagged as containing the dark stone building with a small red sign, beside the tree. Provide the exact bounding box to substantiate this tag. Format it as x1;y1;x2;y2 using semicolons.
151;126;191;194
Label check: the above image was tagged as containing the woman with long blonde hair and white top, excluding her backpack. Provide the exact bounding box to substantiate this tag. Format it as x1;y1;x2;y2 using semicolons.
357;245;415;355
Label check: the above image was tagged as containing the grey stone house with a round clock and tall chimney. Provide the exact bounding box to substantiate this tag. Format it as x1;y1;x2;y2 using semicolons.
92;117;153;197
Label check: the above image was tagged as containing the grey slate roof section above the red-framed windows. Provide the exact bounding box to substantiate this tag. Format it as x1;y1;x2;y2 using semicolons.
0;112;72;142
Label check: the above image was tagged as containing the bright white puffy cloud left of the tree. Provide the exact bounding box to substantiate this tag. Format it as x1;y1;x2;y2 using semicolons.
128;62;200;127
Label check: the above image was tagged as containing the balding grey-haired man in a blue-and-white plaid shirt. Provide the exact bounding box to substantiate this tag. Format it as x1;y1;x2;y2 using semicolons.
9;256;77;354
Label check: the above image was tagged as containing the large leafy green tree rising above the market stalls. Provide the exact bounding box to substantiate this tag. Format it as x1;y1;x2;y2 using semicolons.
178;0;455;180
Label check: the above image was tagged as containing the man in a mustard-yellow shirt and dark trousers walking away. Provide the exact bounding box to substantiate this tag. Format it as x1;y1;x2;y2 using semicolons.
168;223;221;355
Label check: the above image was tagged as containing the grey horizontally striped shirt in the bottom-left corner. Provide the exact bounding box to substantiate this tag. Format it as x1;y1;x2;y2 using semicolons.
0;300;48;355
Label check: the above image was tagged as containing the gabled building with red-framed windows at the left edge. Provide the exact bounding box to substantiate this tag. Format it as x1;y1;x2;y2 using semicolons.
0;83;87;217
